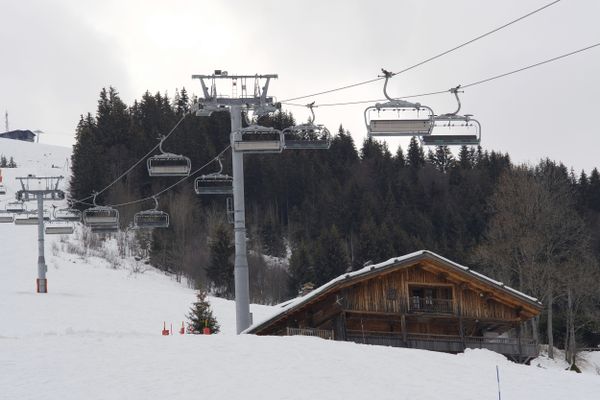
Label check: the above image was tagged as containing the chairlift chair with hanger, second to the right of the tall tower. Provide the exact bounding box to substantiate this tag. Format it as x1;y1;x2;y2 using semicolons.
283;102;331;150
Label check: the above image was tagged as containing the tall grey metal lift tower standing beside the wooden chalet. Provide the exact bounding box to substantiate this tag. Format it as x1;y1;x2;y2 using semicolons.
192;70;283;334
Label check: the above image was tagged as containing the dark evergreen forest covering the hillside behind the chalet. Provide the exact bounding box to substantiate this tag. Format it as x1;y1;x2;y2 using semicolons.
71;88;600;354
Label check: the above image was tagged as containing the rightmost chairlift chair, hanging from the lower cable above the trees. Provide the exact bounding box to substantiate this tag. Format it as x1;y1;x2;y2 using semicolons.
420;85;481;146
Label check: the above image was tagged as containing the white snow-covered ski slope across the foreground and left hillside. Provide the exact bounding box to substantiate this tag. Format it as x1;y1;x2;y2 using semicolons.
0;138;600;400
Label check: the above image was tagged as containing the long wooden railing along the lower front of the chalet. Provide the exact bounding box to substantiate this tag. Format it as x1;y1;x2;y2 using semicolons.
346;331;538;357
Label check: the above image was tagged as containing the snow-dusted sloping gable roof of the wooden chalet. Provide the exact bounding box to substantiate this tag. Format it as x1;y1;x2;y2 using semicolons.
242;250;542;333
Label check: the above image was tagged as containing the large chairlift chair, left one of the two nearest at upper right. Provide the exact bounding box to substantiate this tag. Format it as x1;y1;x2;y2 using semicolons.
364;69;434;137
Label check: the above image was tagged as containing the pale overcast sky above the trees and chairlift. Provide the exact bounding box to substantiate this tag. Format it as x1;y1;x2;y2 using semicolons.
0;0;600;170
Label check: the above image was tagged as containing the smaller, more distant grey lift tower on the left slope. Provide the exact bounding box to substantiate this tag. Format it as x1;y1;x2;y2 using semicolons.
15;175;65;293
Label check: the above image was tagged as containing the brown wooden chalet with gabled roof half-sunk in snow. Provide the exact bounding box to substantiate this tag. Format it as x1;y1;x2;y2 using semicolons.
246;250;542;362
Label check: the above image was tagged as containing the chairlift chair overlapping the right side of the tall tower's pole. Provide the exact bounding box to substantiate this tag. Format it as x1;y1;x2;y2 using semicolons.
231;125;285;153
